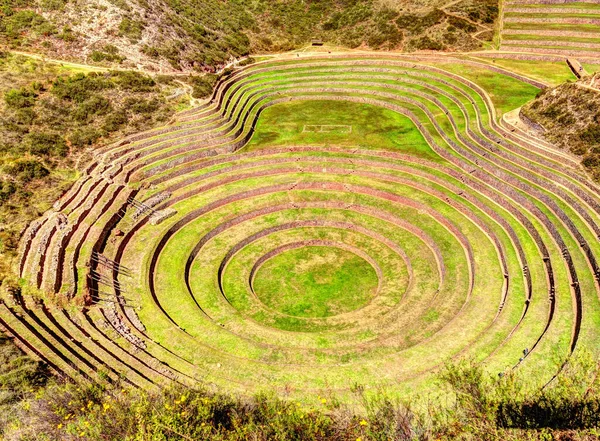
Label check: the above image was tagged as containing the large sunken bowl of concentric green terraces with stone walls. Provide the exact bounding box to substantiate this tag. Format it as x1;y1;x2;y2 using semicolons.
7;56;600;402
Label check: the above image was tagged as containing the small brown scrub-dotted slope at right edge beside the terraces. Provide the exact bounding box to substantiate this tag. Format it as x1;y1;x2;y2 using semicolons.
521;77;600;181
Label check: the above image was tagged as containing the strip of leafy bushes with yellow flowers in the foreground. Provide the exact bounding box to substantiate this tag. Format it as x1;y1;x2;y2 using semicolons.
0;350;600;441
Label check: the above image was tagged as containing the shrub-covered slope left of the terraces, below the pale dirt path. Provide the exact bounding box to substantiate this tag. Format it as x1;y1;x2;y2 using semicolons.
0;54;183;258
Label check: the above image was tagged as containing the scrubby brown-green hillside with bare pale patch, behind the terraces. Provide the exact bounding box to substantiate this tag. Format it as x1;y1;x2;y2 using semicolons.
0;0;498;71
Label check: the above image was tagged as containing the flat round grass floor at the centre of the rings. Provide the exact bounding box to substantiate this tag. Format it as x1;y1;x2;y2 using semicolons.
253;246;379;318
